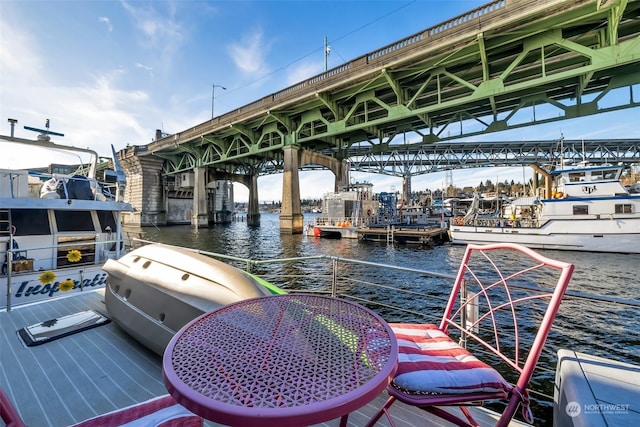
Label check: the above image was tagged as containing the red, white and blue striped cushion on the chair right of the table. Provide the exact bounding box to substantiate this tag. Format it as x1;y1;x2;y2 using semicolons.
391;323;511;394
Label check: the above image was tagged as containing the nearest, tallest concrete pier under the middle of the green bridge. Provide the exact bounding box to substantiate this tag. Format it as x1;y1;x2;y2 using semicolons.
280;147;303;234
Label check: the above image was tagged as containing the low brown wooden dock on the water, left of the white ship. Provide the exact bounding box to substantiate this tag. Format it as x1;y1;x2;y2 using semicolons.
358;225;449;247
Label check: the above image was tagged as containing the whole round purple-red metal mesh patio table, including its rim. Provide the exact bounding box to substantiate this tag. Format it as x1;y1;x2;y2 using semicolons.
163;294;398;426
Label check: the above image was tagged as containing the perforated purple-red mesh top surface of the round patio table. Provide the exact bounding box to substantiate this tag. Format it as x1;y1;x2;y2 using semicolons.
165;295;392;408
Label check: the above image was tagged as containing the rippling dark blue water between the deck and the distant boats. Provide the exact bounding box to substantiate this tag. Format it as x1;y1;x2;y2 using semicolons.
132;214;640;425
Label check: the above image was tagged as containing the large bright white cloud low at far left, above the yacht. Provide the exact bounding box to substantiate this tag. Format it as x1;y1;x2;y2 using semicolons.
0;21;159;162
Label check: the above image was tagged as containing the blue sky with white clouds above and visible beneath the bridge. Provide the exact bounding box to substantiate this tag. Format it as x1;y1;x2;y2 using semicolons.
0;0;640;202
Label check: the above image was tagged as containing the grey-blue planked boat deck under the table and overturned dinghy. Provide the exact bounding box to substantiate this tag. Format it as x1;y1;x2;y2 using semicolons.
0;290;516;427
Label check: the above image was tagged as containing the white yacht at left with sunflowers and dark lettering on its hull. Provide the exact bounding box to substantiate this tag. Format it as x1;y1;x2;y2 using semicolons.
0;126;132;310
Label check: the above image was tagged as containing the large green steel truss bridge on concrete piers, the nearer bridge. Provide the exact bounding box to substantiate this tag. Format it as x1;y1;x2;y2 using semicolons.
120;0;640;233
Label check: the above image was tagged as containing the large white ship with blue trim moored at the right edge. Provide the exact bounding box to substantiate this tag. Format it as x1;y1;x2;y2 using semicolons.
449;164;640;253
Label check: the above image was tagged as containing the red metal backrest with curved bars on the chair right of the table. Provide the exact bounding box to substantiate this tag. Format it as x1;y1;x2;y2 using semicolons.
440;243;574;402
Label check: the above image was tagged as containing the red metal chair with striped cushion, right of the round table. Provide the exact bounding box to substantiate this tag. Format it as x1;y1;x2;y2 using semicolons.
368;243;574;426
